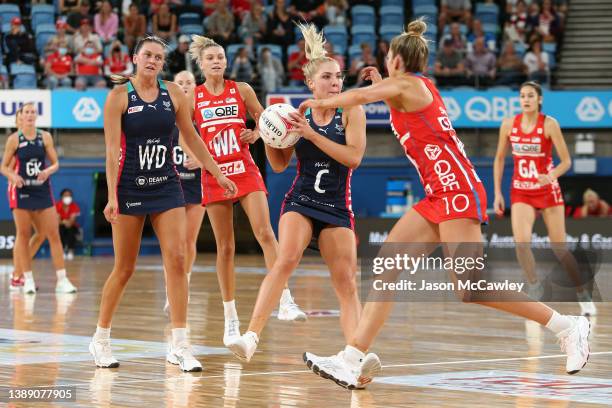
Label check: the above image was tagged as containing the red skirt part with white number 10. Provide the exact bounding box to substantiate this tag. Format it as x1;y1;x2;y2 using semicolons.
414;183;489;224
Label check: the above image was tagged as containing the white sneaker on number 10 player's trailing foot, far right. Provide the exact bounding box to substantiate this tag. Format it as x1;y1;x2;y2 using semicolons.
557;316;591;374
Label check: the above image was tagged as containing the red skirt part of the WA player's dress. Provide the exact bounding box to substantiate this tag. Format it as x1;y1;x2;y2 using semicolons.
202;157;268;206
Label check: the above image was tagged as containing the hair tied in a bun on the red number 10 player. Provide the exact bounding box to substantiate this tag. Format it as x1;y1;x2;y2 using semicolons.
389;18;429;72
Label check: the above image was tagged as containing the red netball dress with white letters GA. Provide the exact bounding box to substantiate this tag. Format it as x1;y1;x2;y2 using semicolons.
508;113;563;209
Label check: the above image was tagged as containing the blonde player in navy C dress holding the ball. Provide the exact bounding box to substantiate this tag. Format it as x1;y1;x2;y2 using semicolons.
229;25;366;361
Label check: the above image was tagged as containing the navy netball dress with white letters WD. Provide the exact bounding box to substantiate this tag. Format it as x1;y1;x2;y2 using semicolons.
117;81;185;215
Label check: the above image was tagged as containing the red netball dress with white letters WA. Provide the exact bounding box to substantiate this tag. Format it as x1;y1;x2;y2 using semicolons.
194;80;268;205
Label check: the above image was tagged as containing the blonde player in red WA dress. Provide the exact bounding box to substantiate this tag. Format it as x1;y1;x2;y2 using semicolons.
189;35;306;345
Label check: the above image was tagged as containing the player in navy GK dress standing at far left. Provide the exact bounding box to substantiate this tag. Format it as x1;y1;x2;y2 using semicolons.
1;103;76;294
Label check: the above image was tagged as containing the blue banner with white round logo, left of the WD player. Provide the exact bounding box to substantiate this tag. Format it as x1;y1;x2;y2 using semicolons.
51;89;108;129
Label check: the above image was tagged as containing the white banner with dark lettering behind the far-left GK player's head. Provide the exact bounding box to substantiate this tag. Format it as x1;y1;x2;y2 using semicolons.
0;89;52;128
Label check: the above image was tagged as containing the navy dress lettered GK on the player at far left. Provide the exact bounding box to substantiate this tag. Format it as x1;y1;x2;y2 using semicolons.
8;129;54;210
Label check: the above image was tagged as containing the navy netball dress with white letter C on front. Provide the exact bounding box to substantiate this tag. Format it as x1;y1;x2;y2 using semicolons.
281;108;355;238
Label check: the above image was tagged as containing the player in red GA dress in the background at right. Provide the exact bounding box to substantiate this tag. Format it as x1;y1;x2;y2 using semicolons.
493;81;597;316
